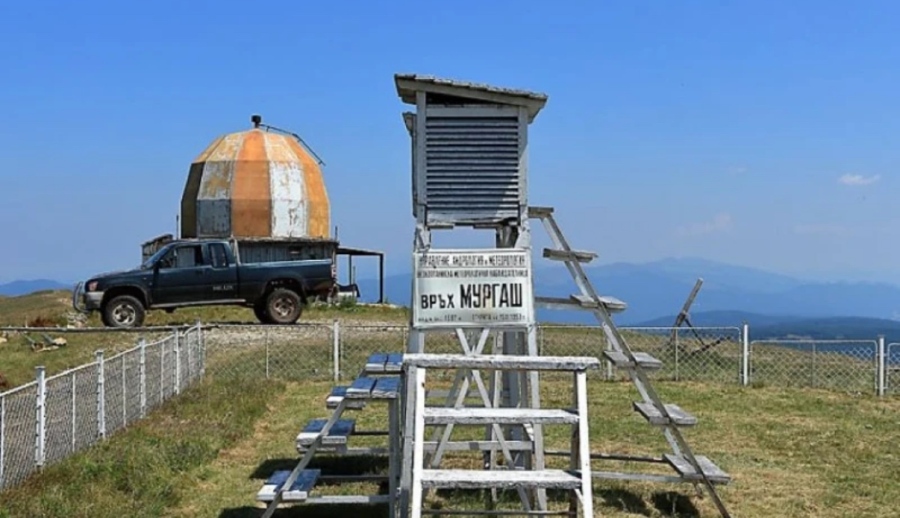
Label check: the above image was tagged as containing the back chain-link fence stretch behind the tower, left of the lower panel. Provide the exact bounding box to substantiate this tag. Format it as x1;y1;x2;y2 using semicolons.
204;322;742;383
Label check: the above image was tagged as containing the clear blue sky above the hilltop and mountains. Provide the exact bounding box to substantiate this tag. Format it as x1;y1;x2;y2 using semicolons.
0;0;900;282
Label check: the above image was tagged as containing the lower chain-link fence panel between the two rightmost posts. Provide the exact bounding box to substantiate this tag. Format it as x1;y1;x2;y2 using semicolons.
750;340;879;393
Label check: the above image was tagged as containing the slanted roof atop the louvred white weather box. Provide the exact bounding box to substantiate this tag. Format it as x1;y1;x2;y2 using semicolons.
394;74;547;122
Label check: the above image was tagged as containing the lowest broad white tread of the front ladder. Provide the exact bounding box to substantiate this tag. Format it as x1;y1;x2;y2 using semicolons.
422;469;581;489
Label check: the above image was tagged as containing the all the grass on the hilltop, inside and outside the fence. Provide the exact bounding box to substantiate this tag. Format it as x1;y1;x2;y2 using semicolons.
0;292;900;518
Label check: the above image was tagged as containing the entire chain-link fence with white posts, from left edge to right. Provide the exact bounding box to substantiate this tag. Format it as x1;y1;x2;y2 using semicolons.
0;316;900;496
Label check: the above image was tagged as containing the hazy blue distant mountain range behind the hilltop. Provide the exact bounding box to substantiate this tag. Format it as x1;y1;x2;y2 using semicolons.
358;258;900;339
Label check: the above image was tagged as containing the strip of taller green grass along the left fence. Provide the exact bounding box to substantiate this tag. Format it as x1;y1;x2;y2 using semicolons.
0;379;283;518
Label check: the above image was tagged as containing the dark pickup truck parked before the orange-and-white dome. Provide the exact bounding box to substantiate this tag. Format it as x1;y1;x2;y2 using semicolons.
72;239;337;328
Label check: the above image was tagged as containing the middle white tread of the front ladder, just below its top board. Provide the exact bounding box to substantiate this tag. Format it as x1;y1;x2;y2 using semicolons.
425;407;578;425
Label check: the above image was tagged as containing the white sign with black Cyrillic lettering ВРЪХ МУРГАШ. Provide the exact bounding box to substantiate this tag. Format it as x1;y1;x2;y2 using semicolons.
412;248;534;328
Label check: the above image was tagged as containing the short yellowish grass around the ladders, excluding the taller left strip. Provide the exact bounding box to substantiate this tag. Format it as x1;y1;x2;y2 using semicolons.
155;376;900;518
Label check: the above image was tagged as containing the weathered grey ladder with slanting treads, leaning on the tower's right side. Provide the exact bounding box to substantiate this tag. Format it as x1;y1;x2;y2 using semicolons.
528;207;731;518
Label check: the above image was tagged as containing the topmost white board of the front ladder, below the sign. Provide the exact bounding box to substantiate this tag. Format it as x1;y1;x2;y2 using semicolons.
403;353;600;371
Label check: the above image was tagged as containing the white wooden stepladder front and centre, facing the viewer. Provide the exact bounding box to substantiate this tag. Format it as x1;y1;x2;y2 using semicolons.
403;353;600;518
